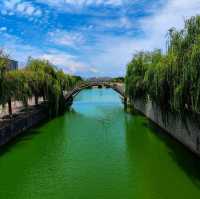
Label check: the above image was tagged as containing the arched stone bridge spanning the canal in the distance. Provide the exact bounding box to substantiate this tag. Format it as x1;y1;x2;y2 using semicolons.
65;82;127;105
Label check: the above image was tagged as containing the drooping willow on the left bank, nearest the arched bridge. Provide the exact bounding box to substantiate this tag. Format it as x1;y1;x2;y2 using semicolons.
25;58;79;116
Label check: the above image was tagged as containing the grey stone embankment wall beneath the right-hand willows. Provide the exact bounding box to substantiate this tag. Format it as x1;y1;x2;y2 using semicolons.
133;100;200;157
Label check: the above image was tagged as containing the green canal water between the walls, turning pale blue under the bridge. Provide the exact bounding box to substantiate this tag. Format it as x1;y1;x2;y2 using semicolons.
0;89;200;199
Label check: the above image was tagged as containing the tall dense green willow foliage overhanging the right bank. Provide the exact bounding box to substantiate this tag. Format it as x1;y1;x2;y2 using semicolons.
126;16;200;114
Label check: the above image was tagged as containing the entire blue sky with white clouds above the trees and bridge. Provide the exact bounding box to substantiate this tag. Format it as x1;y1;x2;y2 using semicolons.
0;0;200;77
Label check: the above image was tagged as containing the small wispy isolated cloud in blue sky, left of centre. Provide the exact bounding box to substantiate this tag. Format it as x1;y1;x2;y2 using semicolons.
47;29;84;48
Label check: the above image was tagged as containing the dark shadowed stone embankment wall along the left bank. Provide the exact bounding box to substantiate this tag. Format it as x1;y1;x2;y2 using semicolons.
0;105;48;146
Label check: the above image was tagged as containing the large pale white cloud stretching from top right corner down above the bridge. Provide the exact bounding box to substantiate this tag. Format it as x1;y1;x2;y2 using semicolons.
77;0;200;75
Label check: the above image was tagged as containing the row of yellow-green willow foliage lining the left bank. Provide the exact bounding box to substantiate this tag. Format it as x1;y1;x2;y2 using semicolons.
0;58;81;116
